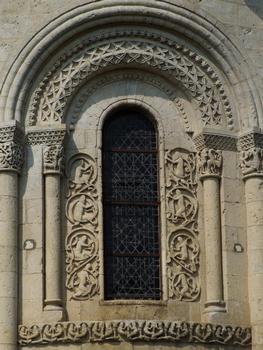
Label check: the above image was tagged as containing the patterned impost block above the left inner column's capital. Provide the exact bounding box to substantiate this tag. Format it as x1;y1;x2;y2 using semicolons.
26;126;66;146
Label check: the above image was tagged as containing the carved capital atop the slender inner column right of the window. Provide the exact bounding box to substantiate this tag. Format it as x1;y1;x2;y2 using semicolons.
197;148;223;179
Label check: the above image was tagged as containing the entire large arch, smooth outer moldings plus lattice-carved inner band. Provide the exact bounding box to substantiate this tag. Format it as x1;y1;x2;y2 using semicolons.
1;0;262;131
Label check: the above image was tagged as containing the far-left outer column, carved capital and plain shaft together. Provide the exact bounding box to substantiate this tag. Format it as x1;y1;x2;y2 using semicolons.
0;124;23;350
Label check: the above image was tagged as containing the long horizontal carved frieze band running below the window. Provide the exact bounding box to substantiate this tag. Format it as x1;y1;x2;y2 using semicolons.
18;320;251;347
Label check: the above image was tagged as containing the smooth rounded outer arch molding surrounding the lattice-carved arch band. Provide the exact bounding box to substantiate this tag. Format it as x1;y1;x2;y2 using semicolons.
2;0;262;133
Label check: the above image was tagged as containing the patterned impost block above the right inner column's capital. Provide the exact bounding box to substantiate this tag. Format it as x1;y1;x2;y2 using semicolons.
193;133;237;152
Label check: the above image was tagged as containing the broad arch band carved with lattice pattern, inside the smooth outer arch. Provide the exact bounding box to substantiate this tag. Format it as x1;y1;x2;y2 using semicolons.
29;30;233;129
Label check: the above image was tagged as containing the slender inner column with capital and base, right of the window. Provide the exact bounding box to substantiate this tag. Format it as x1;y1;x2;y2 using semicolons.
198;148;225;321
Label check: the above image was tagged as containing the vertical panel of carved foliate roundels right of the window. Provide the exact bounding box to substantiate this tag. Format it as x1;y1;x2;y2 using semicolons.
165;149;200;301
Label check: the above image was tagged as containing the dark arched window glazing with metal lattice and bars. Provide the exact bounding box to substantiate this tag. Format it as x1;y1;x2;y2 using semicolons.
102;109;161;300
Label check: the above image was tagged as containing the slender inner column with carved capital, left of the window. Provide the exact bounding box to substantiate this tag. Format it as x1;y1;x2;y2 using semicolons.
43;145;63;310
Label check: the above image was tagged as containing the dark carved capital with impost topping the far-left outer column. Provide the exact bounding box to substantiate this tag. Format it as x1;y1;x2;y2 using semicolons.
0;125;24;172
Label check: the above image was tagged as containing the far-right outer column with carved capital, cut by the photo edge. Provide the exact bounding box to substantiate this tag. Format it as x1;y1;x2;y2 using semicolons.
241;141;263;350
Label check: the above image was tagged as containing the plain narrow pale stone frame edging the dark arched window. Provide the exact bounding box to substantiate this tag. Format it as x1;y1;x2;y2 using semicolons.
97;98;168;305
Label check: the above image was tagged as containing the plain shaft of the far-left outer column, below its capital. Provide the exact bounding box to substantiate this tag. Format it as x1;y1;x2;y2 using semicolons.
0;171;18;350
